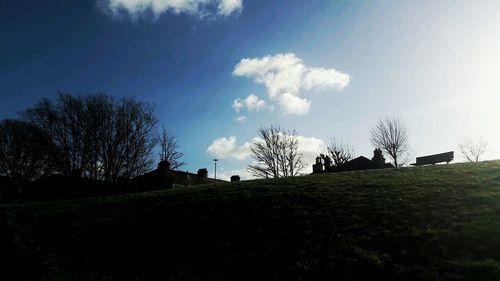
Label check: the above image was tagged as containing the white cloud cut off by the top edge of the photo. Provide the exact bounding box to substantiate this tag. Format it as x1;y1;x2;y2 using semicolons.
98;0;243;20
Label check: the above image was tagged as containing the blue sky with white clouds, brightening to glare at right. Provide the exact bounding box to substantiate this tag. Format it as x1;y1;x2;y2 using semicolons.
0;0;500;179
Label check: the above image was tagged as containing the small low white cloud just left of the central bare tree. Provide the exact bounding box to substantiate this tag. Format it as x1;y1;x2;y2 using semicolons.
207;136;251;161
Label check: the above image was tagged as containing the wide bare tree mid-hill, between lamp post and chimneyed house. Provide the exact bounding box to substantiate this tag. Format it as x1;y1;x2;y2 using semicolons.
248;125;305;178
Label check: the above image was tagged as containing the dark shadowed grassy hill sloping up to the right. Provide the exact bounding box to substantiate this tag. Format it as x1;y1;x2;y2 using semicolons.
0;161;500;280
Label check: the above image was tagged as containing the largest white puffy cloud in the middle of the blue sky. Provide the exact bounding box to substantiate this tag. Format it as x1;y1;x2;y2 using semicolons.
233;53;351;115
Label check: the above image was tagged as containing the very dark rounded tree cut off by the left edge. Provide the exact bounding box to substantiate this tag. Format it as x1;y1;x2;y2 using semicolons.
0;119;47;187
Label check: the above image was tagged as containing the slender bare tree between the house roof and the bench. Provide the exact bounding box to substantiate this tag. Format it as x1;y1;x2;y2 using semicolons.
370;117;410;167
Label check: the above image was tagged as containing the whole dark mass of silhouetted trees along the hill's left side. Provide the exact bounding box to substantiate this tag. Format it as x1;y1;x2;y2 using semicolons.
0;93;182;186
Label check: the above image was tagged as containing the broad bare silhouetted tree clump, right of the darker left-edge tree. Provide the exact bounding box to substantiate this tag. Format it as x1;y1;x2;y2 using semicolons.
21;93;158;181
